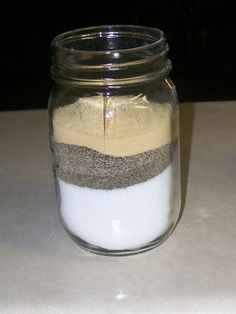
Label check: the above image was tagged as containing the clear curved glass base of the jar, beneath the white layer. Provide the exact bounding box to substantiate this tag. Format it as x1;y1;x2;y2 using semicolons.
65;224;175;257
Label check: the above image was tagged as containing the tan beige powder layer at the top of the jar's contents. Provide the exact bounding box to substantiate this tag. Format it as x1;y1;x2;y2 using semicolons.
53;96;172;157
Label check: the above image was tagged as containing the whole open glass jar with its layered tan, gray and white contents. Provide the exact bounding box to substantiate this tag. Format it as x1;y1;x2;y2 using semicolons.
49;25;180;256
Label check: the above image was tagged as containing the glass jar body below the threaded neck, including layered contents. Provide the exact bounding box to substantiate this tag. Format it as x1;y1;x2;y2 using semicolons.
49;25;180;255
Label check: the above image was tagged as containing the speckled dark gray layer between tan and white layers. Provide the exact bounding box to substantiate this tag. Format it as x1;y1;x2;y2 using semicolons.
52;142;172;190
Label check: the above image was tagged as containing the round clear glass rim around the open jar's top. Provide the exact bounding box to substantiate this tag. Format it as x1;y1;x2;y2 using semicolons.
51;24;165;55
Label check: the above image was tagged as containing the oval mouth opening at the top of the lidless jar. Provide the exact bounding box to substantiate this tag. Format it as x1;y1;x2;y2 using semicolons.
52;25;165;57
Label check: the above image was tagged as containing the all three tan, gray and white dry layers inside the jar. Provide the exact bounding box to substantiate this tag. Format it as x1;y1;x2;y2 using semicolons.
52;95;174;250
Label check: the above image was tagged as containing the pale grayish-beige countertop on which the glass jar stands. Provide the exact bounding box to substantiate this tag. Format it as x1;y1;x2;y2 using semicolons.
0;101;236;314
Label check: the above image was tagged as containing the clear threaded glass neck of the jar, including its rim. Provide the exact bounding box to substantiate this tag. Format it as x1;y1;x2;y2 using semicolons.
51;25;171;86
